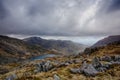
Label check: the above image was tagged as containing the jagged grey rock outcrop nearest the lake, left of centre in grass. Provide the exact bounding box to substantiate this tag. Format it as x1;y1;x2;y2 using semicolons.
34;60;80;73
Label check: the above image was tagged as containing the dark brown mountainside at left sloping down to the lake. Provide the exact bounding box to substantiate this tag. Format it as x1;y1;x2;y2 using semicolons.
0;35;55;64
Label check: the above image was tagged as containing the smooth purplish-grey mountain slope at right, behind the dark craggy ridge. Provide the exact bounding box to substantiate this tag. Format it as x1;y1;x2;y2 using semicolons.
92;35;120;48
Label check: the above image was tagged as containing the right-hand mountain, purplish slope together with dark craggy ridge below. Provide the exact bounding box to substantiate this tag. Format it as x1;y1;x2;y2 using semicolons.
84;35;120;54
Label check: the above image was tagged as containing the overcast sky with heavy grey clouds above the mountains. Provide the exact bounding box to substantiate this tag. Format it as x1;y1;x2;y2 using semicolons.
0;0;120;44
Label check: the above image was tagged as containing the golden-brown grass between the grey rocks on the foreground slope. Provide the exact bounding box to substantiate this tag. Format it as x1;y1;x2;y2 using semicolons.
0;45;120;80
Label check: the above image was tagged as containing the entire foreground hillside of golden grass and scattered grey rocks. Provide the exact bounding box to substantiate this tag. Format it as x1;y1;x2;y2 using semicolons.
0;35;120;80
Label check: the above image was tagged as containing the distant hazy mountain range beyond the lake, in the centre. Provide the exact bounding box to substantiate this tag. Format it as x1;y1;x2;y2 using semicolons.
24;37;85;54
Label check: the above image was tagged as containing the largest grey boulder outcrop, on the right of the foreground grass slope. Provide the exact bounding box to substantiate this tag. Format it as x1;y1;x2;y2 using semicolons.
70;56;120;76
